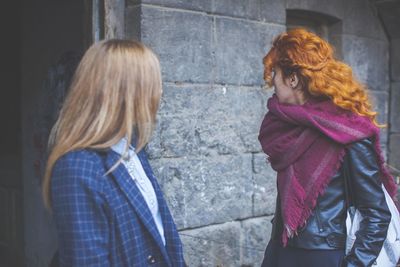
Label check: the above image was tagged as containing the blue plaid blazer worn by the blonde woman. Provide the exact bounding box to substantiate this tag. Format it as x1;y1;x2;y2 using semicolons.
51;149;185;267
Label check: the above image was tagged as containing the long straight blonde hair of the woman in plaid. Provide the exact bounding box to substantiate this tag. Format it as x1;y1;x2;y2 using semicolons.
42;39;162;208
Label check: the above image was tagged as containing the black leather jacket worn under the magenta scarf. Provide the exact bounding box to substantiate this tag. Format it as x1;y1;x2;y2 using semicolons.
272;139;391;267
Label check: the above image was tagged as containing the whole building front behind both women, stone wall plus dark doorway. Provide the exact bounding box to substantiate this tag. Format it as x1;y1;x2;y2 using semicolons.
0;0;400;267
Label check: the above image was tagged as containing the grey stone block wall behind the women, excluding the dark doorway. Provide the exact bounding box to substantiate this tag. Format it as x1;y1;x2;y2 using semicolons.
125;0;390;266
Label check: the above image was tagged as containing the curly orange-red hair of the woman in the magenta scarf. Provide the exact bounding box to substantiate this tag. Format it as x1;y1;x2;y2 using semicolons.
263;28;379;125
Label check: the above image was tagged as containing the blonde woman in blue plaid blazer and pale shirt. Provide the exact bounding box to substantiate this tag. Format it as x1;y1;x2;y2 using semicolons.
43;40;184;267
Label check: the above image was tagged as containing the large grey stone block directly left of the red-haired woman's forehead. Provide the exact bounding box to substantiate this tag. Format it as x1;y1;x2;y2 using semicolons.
214;18;285;85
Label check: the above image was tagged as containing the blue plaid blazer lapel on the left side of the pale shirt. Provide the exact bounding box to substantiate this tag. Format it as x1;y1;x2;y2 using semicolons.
106;152;171;266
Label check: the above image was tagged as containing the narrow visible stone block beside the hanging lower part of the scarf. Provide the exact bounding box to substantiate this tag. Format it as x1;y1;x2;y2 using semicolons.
253;153;277;216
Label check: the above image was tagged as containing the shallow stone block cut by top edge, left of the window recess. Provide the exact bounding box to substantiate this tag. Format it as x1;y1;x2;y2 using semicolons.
212;0;286;24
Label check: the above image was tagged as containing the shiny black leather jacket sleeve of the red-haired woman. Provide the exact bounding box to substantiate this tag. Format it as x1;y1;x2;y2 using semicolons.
342;139;391;267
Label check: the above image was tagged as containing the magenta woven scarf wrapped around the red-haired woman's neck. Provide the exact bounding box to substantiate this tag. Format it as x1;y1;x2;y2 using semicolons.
258;95;397;246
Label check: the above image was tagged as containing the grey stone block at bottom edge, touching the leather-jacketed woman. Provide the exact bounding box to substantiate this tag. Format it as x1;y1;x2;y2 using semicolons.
241;216;273;266
